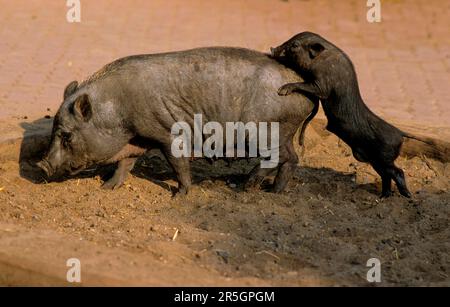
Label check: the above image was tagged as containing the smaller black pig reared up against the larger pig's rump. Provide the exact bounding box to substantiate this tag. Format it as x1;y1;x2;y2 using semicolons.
272;32;427;197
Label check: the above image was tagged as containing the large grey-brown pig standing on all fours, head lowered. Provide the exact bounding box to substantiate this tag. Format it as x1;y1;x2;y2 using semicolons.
38;47;318;194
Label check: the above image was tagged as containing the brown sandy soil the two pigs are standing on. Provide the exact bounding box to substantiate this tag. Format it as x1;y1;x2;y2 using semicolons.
0;119;450;286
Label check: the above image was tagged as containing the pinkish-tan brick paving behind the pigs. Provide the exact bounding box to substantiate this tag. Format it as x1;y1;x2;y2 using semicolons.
0;0;450;141
